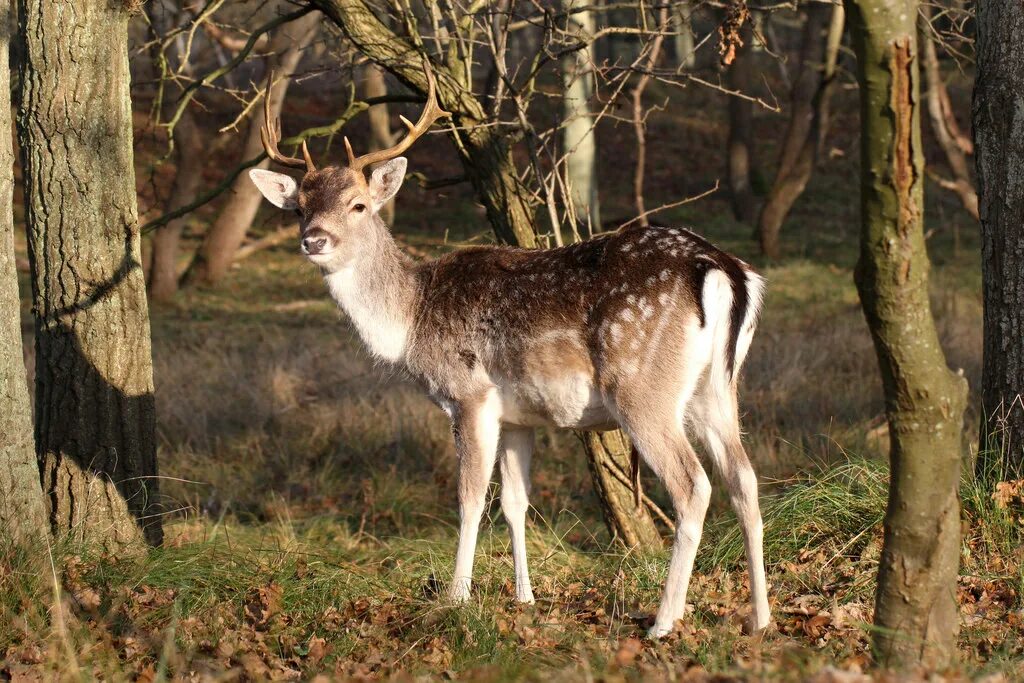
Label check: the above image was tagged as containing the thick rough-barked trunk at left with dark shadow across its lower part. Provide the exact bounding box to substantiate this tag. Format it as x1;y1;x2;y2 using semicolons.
17;0;162;554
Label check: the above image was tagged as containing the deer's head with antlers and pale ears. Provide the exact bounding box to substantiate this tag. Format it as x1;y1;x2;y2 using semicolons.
249;65;451;269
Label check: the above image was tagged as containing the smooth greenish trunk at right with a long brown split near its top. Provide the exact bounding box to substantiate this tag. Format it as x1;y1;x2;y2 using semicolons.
846;0;967;668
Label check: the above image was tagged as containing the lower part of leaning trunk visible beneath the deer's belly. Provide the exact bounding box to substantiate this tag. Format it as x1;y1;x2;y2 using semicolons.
582;430;663;549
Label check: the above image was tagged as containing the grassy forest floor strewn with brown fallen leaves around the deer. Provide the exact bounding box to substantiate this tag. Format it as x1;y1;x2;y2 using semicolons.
8;65;1024;682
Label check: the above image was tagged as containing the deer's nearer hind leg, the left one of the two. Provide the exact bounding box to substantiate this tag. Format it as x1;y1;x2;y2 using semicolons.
616;368;711;638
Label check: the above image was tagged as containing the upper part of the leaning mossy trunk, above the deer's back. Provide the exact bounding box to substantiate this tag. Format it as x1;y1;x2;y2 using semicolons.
309;0;537;247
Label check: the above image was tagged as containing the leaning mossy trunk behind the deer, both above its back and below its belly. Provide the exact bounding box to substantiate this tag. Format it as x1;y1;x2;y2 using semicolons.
309;0;662;548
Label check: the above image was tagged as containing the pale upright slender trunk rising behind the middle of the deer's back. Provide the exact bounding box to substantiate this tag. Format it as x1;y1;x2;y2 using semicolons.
562;0;601;234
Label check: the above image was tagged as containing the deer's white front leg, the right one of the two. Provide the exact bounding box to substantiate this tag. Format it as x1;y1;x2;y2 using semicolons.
501;429;534;603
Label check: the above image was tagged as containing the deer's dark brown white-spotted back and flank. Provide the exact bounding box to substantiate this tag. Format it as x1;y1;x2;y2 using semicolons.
409;227;745;427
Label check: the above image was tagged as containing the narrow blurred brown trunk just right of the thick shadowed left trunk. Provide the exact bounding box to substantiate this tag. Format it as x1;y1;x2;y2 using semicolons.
146;109;206;301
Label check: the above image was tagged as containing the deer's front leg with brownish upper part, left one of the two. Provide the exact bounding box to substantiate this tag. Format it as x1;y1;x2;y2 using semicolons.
449;391;501;602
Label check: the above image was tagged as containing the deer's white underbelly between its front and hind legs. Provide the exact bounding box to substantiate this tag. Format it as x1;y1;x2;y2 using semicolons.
498;373;617;429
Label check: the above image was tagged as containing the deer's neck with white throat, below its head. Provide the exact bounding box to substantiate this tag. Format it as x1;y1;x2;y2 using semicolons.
325;221;418;362
